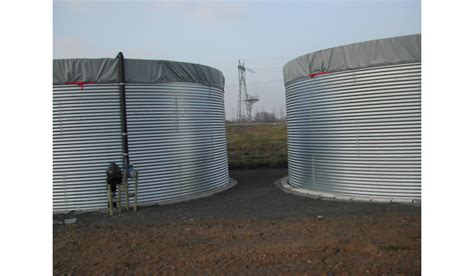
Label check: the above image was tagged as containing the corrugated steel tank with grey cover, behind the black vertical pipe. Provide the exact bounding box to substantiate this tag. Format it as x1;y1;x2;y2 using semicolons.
53;55;229;212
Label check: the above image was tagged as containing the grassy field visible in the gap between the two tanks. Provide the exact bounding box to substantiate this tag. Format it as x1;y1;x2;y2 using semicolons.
227;123;288;169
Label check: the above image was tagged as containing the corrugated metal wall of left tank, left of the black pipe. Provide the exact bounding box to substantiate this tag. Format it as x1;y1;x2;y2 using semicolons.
53;85;123;212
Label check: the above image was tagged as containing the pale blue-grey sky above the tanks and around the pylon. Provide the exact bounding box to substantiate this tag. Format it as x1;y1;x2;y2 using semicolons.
53;0;421;119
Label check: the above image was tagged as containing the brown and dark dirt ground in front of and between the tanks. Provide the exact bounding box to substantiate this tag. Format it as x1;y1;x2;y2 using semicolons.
53;169;421;275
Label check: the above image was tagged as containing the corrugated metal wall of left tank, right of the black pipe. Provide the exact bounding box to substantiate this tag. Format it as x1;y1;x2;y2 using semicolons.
126;83;229;204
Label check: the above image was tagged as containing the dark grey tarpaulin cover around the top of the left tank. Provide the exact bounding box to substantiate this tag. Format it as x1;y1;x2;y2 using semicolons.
53;58;225;89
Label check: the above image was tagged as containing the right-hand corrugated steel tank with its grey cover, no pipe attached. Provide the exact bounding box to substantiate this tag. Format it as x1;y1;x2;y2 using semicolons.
283;35;421;202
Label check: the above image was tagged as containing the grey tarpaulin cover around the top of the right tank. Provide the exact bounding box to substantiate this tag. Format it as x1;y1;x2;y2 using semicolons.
283;34;421;84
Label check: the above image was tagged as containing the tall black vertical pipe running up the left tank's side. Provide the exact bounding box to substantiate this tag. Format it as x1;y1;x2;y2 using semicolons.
117;52;130;170
